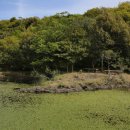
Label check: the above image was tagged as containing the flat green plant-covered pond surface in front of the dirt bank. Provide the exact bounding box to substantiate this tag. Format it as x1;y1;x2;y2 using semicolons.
0;83;130;130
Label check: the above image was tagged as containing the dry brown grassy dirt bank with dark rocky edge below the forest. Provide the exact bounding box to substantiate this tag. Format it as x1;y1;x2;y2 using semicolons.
15;73;130;93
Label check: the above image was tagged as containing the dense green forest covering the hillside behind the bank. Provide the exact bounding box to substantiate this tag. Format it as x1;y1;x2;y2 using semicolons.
0;2;130;73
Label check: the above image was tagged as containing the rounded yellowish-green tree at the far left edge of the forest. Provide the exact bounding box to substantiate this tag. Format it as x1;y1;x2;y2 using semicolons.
0;36;19;70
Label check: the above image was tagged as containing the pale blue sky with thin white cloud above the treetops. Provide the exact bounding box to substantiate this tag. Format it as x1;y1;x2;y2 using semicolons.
0;0;130;19
